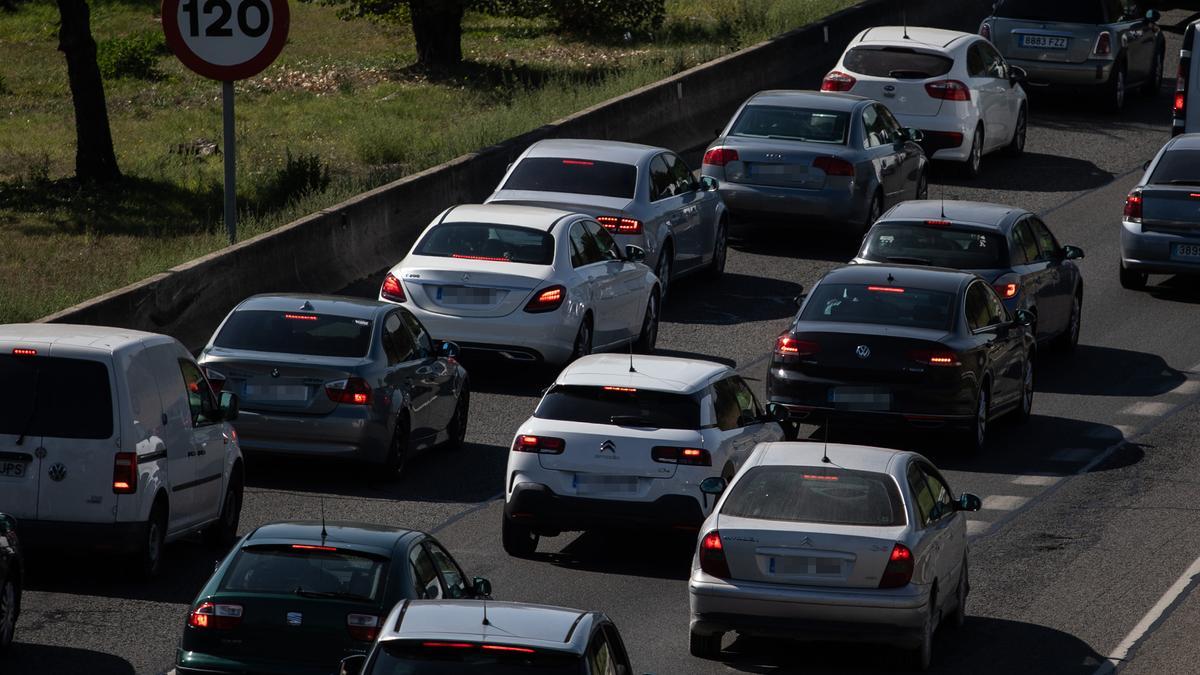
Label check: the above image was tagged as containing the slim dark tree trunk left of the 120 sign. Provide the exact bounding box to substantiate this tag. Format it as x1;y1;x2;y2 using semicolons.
58;0;121;183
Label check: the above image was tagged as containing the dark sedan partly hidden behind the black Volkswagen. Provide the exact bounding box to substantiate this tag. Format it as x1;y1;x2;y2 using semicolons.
854;201;1084;350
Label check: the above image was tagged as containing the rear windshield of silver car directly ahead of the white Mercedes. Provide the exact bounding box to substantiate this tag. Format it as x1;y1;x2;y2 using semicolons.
503;157;637;199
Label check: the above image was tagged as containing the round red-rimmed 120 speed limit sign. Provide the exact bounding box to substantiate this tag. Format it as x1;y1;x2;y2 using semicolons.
162;0;288;80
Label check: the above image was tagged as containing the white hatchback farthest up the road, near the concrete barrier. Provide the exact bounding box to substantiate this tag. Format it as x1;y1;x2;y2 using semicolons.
821;25;1028;178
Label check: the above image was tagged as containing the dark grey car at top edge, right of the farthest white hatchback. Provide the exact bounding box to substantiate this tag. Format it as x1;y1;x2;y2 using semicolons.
979;0;1166;110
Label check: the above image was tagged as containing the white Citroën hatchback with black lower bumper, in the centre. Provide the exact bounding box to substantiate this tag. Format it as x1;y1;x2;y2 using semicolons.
503;354;784;556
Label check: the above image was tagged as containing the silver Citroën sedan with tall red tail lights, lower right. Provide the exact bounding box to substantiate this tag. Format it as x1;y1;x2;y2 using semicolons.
688;442;980;670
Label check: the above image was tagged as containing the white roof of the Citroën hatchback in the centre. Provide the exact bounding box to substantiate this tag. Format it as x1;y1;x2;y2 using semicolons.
554;354;733;394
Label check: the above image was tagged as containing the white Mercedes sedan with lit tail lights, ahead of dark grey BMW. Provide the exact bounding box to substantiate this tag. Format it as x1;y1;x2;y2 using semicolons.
379;204;660;364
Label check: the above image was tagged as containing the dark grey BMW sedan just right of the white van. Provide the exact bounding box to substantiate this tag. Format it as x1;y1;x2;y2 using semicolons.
198;294;470;477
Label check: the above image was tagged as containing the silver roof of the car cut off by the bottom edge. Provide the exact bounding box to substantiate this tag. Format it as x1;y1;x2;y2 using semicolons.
379;599;595;653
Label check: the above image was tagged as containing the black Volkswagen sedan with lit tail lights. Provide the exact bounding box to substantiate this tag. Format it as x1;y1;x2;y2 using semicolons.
767;264;1037;449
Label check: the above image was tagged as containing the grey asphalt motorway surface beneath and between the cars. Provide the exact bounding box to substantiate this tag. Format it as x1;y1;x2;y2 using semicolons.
9;11;1200;675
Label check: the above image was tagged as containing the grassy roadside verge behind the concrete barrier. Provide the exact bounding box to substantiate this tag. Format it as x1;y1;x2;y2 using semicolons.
0;0;854;323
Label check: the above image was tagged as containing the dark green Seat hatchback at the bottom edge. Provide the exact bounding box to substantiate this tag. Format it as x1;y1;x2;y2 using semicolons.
175;522;491;675
